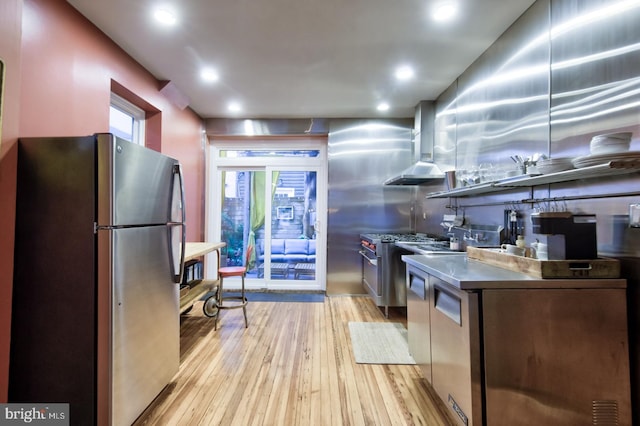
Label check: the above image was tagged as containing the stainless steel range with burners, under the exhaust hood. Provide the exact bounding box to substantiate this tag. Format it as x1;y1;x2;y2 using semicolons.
360;233;463;317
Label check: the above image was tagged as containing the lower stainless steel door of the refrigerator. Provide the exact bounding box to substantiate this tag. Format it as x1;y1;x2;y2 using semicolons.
105;226;180;424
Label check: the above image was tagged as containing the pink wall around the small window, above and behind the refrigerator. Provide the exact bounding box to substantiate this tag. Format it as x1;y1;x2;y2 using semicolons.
20;0;204;241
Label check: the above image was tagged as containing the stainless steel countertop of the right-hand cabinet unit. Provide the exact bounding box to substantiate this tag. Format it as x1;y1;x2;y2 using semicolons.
402;254;627;290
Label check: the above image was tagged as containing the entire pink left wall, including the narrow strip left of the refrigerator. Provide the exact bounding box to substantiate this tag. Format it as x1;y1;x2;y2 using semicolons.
0;0;205;402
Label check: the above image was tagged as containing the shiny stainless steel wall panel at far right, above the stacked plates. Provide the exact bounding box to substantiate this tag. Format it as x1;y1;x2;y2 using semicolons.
550;0;640;156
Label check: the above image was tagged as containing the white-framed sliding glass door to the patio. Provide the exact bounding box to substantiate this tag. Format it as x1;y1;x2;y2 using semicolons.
208;141;326;290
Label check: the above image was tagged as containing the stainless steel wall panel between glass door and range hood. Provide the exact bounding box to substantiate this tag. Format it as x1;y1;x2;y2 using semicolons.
327;119;415;294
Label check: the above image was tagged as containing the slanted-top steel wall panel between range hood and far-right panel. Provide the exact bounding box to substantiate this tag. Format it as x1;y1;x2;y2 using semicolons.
456;1;550;175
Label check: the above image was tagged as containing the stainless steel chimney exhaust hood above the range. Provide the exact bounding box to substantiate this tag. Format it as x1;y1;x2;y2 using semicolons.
384;101;444;185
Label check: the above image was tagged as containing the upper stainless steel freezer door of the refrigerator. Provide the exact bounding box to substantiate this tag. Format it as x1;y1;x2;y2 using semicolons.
96;133;184;226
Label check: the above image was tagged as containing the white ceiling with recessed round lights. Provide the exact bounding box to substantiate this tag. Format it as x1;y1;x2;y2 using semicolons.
68;0;534;118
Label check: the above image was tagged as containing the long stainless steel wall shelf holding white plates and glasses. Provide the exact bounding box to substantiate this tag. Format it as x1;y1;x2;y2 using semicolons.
426;159;640;198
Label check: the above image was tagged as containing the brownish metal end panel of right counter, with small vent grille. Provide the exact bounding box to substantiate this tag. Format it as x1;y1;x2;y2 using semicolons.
482;289;631;426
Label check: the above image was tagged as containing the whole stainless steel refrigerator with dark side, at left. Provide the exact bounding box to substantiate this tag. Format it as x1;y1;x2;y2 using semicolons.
9;134;185;425
